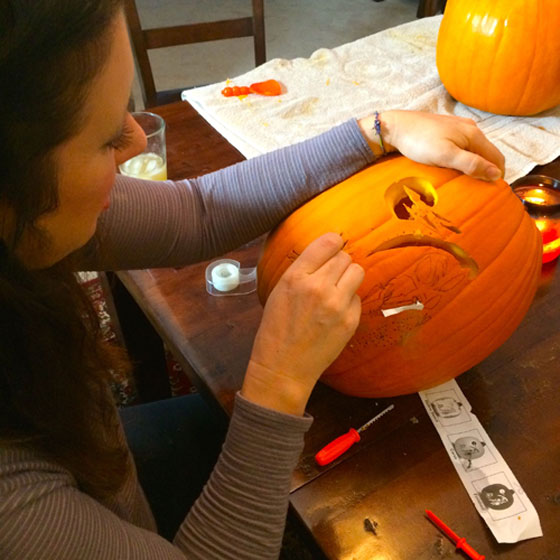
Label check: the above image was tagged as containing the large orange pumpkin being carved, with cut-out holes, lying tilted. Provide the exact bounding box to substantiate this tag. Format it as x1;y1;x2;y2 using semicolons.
257;156;542;397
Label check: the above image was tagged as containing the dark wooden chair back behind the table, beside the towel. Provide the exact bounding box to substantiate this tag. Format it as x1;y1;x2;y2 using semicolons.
124;0;266;108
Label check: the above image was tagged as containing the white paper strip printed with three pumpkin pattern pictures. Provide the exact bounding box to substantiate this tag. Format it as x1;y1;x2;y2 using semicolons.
418;380;542;543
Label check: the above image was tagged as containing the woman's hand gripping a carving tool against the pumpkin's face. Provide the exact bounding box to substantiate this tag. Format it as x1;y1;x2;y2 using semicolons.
241;233;364;414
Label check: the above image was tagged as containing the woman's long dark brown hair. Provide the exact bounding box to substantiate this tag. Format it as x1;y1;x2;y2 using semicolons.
0;0;129;497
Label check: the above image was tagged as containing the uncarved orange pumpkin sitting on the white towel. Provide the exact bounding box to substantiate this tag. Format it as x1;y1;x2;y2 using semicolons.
436;0;560;115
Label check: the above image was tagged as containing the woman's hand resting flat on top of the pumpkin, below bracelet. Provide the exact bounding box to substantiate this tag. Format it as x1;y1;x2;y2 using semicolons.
358;111;505;181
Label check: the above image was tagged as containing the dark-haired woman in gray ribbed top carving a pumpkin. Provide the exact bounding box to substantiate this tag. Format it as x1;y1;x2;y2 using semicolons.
0;0;503;560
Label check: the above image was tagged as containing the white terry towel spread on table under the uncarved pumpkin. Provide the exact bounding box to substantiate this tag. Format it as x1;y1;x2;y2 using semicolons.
183;16;560;183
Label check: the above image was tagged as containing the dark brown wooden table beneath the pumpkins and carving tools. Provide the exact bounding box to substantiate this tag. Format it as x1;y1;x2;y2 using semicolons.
118;103;560;560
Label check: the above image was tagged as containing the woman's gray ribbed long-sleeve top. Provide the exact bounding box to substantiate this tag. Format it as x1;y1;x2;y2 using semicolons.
0;121;374;560
